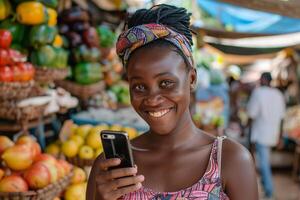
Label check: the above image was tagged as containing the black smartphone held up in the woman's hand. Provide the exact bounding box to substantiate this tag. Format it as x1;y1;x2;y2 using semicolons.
100;130;134;169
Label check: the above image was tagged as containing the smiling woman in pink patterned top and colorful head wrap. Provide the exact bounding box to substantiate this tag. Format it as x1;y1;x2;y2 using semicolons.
87;4;258;200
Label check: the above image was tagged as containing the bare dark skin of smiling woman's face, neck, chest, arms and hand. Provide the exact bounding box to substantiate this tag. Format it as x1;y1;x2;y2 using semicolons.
87;47;258;200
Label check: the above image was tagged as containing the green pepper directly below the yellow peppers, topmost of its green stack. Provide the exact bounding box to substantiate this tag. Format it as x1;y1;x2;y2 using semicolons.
29;24;58;48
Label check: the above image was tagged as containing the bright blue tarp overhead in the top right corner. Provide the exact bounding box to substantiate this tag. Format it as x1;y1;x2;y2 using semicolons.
198;0;300;34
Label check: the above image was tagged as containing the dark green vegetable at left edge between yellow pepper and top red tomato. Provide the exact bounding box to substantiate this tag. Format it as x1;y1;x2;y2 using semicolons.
0;19;26;43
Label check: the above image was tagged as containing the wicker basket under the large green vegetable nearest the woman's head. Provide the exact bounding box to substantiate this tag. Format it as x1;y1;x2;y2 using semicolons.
55;80;105;100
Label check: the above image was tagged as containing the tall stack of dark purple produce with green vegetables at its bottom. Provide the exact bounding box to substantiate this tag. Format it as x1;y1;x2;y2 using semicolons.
59;7;103;85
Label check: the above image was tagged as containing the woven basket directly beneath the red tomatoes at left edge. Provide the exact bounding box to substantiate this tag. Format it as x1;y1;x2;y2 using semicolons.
0;81;34;101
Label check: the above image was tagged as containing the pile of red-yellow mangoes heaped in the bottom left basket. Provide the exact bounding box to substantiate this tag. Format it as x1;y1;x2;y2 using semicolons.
0;136;72;197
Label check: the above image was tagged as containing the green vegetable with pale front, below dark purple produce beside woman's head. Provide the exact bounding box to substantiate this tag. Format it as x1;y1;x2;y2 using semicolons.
73;62;102;85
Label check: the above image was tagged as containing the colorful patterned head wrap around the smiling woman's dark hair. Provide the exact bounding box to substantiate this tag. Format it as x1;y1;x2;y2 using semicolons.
116;23;194;67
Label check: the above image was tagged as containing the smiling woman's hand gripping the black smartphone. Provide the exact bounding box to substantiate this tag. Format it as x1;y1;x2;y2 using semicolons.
96;158;144;200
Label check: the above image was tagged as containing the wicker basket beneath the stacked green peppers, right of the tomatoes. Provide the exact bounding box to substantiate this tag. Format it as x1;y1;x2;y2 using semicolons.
34;67;69;84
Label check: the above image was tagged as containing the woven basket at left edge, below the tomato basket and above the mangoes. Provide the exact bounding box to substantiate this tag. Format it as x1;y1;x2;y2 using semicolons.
0;101;48;121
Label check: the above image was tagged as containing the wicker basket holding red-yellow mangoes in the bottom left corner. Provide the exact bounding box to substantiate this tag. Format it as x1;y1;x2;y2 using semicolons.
0;170;73;200
